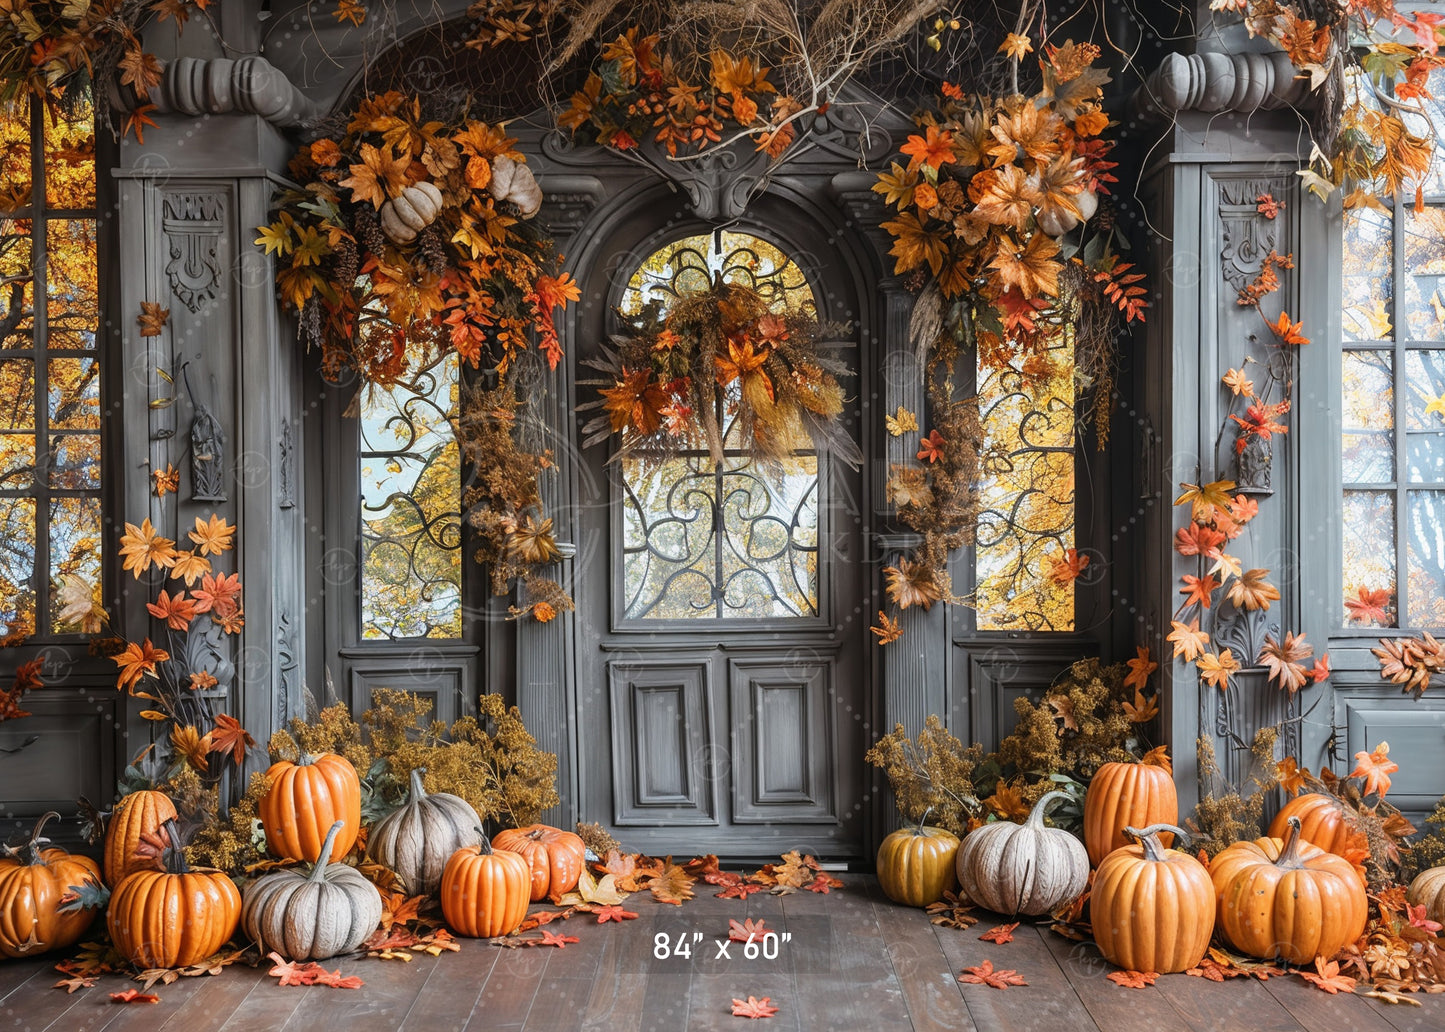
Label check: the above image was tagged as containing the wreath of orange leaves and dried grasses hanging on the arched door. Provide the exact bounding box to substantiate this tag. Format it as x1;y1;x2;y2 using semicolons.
579;268;863;467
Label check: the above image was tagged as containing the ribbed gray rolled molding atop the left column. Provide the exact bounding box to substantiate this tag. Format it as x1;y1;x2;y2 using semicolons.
150;58;325;129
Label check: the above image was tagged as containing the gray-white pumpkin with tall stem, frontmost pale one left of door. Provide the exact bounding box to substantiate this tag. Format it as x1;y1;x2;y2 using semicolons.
241;821;381;960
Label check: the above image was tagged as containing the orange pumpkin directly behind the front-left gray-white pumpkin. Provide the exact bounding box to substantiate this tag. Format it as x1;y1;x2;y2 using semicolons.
257;753;361;863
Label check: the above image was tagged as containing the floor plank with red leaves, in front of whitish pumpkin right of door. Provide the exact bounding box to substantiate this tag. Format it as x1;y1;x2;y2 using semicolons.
929;916;1095;1031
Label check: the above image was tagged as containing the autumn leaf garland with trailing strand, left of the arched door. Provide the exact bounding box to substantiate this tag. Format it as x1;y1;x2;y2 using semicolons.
256;91;581;619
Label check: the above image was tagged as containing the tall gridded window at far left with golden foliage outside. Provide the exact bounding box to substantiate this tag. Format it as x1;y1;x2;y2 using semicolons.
0;98;103;640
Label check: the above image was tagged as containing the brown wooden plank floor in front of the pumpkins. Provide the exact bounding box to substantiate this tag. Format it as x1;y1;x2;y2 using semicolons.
0;874;1445;1032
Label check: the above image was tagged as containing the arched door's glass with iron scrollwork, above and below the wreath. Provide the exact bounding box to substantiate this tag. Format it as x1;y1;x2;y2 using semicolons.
614;230;824;622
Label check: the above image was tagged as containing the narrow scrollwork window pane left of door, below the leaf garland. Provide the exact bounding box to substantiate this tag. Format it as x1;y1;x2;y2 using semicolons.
361;354;461;639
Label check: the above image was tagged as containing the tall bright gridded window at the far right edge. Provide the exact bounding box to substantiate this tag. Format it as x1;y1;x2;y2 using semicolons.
1335;79;1445;629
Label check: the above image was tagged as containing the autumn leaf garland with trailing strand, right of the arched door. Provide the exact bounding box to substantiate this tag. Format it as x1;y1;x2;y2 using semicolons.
873;33;1147;643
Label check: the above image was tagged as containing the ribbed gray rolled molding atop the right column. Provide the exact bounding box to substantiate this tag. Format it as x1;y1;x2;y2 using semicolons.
1133;51;1314;119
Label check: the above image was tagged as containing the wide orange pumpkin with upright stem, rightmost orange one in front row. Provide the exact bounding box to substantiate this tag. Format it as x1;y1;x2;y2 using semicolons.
1209;817;1370;964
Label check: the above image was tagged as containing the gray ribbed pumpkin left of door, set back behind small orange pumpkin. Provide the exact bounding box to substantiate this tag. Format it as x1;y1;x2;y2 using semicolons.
367;767;481;896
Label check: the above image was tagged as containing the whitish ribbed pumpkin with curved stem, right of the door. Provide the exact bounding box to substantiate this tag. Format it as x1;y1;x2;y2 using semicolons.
958;792;1088;915
